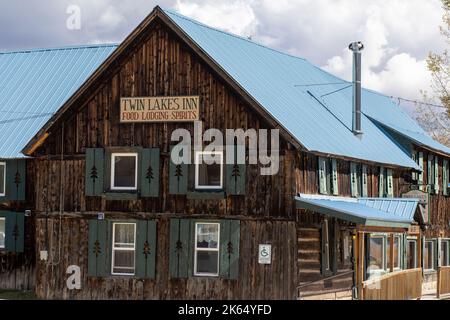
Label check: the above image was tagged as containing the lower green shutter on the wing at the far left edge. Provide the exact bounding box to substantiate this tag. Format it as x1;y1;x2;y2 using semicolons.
0;211;25;253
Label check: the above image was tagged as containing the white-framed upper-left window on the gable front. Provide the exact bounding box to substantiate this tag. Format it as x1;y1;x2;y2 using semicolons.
111;153;138;191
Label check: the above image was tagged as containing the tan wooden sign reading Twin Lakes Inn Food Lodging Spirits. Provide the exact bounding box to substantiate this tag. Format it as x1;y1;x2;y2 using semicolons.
120;96;200;123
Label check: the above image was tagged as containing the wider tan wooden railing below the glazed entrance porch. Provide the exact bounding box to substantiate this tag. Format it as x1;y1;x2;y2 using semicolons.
361;269;422;300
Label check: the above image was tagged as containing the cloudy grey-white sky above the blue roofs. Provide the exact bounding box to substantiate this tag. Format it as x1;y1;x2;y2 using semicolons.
0;0;445;105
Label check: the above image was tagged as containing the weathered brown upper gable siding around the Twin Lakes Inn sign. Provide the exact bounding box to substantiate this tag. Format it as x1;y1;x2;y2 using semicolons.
36;20;294;217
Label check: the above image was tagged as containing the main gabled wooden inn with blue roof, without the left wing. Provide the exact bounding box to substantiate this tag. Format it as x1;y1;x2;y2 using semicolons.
0;7;450;300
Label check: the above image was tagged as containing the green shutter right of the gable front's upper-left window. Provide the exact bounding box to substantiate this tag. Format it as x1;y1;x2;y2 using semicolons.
140;148;160;198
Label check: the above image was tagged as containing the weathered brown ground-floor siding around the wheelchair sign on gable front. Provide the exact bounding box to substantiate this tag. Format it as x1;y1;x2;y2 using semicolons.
36;214;297;300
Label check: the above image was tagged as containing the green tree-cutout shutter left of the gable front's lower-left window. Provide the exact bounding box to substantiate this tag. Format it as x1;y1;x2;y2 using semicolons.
88;220;112;277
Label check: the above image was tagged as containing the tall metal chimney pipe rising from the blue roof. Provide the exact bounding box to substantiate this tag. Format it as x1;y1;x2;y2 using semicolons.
348;41;364;135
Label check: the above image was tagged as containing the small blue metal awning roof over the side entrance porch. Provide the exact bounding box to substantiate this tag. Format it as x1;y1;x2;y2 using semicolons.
295;197;419;228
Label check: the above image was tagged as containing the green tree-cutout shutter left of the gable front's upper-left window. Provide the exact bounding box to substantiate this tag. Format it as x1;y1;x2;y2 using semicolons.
85;148;104;197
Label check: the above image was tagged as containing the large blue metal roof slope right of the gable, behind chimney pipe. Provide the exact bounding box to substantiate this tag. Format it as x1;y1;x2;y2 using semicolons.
164;10;450;169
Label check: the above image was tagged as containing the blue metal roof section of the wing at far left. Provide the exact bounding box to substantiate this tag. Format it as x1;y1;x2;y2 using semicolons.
0;45;116;159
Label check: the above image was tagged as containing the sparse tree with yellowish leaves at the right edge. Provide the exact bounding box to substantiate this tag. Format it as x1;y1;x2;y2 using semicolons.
417;0;450;146
